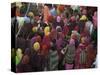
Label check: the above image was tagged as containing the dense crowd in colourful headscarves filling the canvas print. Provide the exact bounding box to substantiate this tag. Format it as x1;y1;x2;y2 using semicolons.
11;2;98;72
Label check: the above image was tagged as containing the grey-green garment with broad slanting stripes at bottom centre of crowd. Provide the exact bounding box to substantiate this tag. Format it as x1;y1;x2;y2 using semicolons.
49;50;58;70
